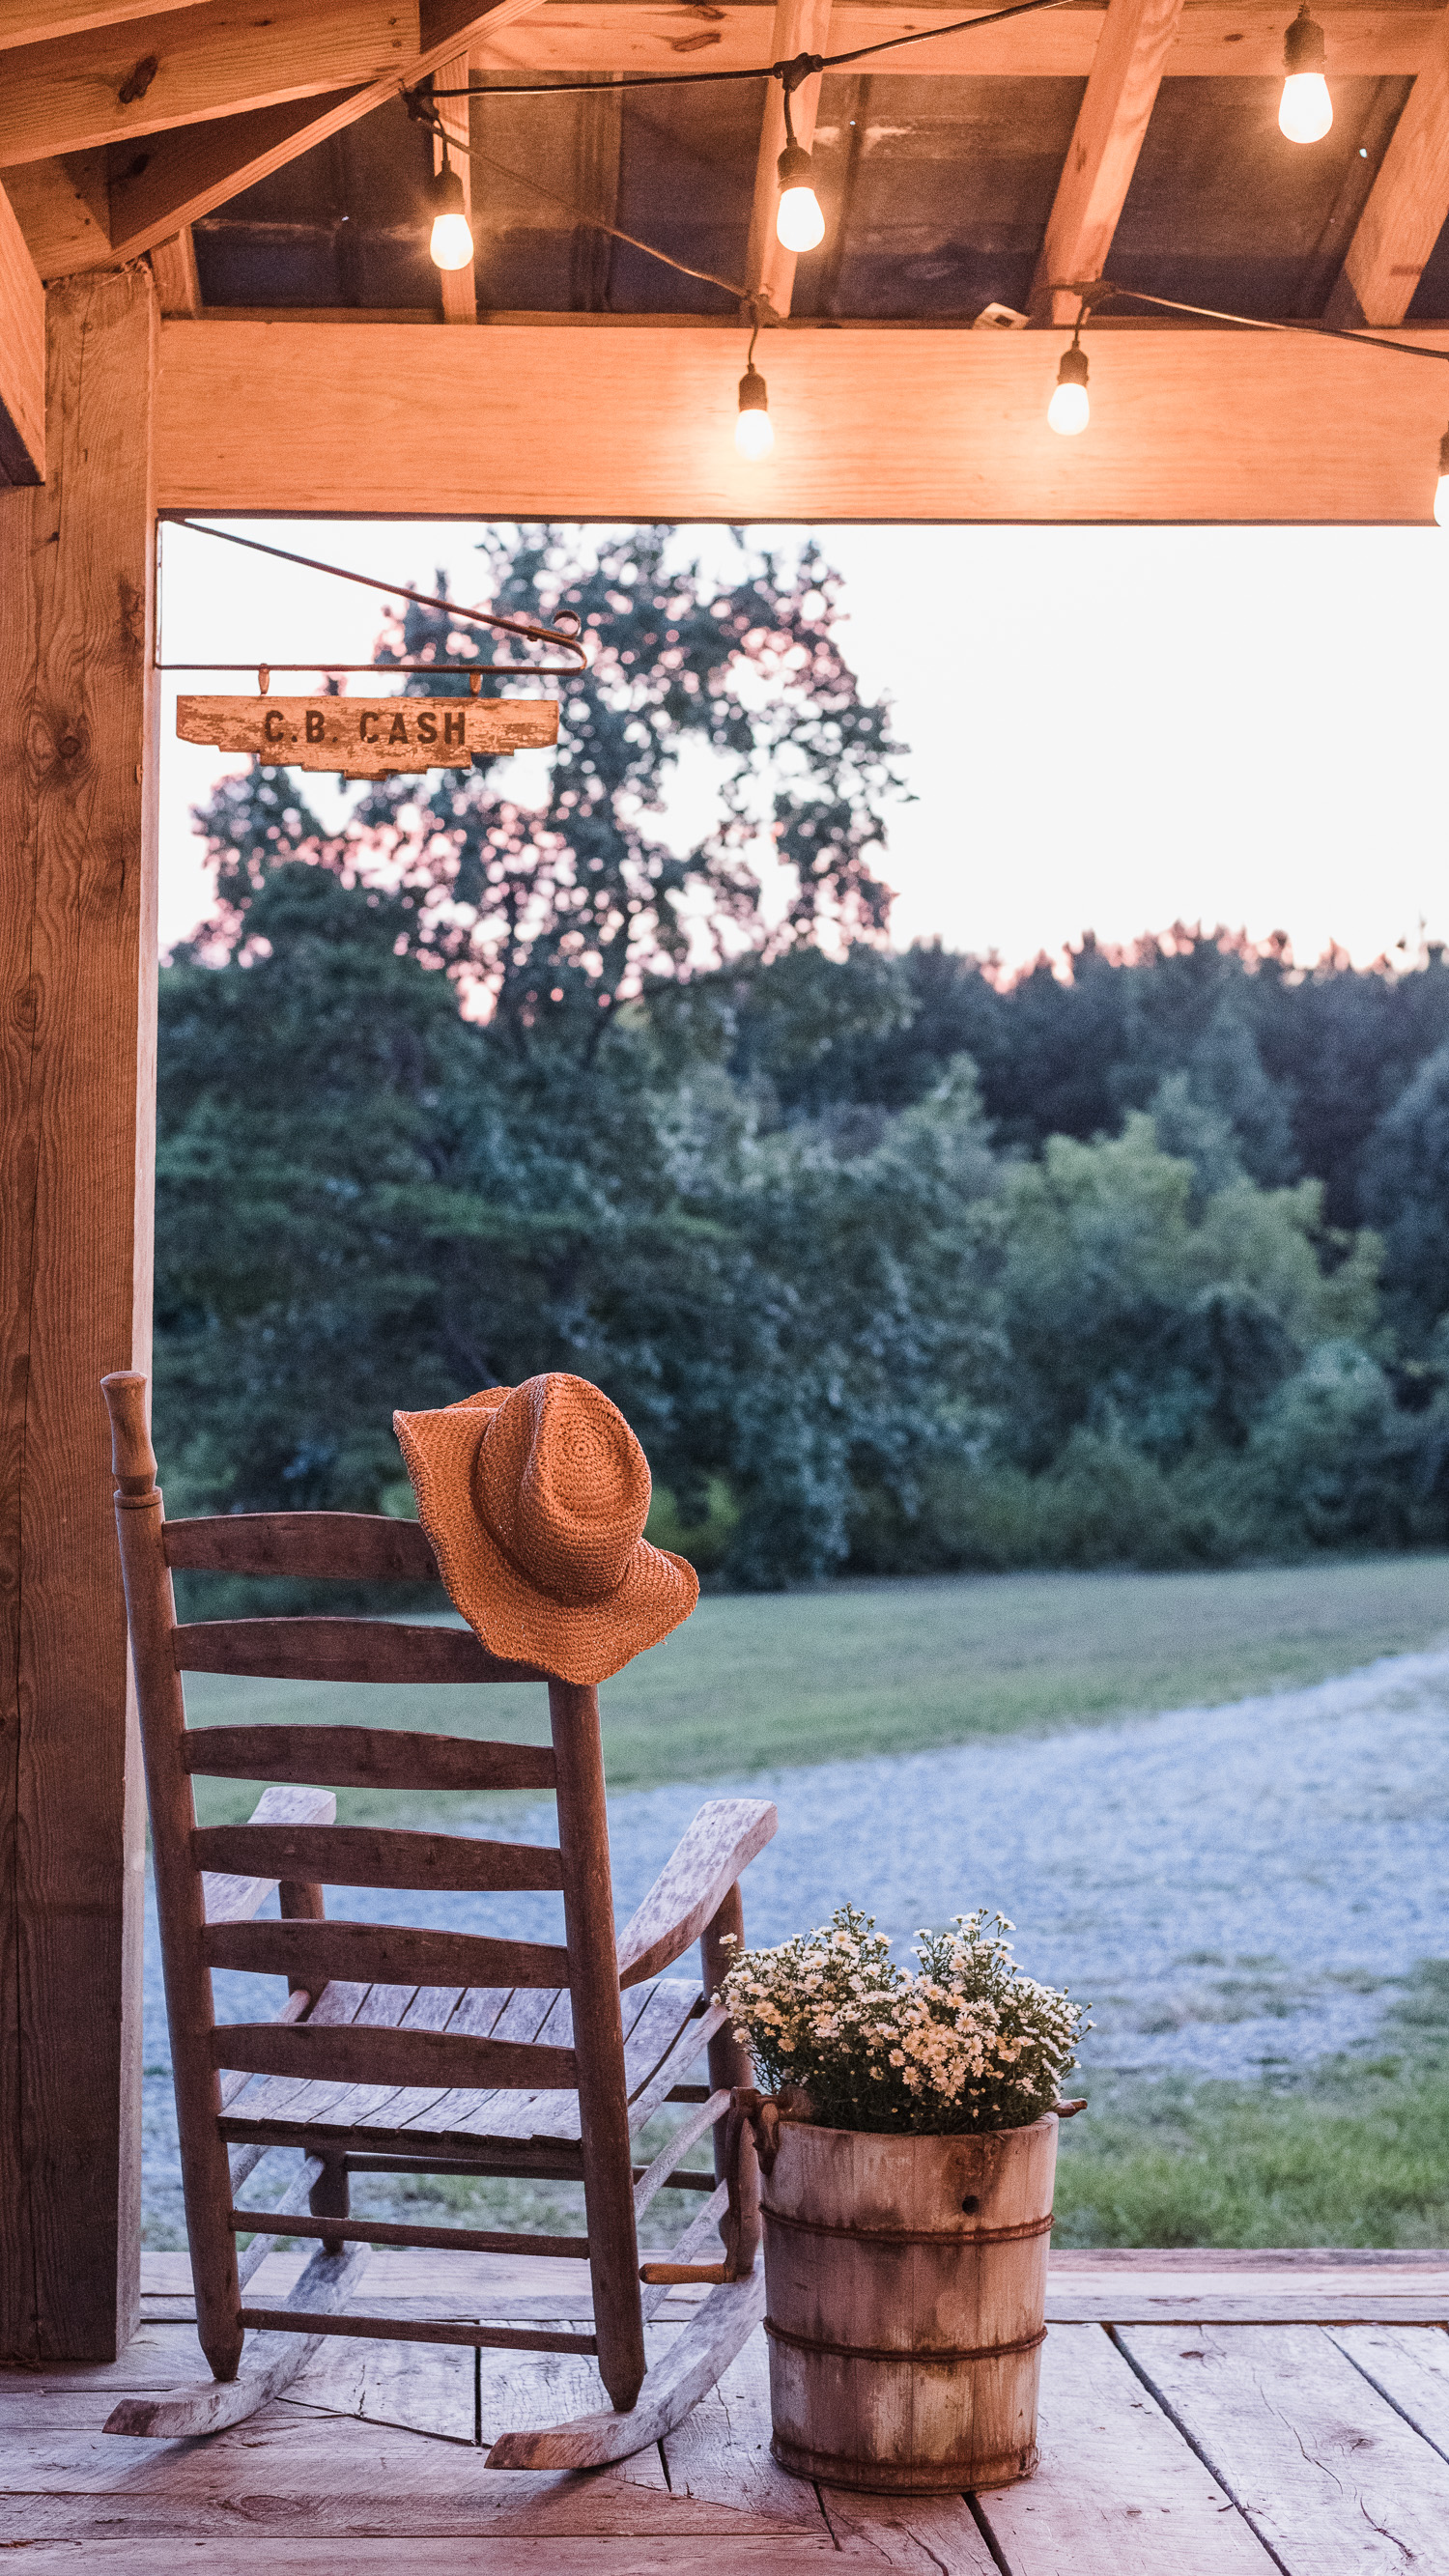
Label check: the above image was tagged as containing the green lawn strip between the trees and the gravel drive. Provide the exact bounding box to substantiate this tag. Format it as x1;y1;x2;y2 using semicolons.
185;1556;1449;1822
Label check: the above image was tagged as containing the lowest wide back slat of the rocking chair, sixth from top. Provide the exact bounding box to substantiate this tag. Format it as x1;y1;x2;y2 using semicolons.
212;2023;578;2091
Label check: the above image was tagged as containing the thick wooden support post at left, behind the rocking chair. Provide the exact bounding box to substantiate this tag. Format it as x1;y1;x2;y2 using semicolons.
0;270;156;2363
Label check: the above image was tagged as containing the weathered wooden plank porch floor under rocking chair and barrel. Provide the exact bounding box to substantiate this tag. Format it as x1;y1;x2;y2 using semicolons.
0;2254;1449;2576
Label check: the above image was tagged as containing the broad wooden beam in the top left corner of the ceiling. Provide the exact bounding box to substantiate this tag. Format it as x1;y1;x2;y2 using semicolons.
0;0;417;167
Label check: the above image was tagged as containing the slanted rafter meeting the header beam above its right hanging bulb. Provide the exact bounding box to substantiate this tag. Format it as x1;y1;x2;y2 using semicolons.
1032;0;1183;322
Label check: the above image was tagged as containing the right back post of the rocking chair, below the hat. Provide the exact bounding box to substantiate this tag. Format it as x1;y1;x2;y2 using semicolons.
550;1683;644;2409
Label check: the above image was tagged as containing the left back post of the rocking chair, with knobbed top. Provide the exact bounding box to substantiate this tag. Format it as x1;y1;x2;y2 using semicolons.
100;1371;242;2378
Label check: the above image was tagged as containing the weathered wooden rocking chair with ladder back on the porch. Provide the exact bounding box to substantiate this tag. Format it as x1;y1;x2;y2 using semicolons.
103;1373;776;2468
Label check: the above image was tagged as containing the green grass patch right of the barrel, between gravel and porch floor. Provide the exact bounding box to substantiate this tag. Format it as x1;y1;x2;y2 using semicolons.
1055;1961;1449;2247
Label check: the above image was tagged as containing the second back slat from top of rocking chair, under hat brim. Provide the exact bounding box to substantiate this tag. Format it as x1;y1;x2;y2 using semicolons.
170;1618;550;1683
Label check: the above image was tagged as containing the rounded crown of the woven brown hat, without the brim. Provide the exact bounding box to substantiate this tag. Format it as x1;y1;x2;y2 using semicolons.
471;1371;650;1607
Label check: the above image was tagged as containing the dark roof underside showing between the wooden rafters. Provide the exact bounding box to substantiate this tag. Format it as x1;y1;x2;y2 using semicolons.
180;52;1449;325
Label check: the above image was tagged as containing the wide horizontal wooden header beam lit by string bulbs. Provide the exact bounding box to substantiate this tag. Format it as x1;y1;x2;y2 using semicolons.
157;322;1449;520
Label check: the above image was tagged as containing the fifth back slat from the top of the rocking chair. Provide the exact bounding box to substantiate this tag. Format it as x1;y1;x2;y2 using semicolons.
201;1922;567;1988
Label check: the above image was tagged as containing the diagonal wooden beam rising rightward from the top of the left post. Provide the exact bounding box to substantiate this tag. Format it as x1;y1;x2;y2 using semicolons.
57;0;536;275
